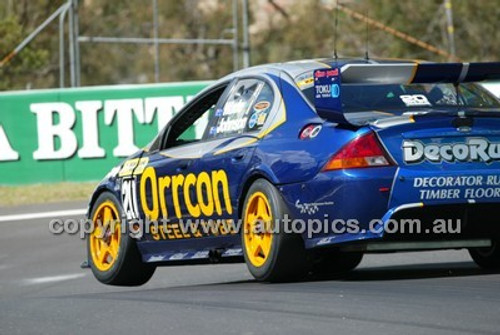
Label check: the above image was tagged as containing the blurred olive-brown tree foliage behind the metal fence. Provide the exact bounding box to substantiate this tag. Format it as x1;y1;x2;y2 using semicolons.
0;0;500;90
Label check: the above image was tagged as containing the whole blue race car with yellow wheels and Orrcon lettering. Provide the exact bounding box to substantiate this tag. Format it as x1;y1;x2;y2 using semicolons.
87;59;500;285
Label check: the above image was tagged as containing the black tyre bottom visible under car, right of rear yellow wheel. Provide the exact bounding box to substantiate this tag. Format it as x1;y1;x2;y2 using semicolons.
312;249;363;277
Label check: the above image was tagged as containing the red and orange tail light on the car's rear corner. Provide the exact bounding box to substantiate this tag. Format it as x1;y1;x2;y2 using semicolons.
323;132;393;171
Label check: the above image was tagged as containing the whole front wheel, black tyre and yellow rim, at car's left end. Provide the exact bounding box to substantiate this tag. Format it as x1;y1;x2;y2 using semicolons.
87;192;156;286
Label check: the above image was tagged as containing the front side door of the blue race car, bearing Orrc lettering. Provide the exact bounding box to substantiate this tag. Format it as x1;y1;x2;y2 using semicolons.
136;83;230;241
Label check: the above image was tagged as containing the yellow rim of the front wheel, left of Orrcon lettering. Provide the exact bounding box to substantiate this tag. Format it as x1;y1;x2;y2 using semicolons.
89;201;121;271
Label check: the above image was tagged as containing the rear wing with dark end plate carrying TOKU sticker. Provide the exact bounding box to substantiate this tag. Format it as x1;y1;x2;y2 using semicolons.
313;62;500;125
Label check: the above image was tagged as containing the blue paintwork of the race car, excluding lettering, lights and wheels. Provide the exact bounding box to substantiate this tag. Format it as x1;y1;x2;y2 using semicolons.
89;60;500;263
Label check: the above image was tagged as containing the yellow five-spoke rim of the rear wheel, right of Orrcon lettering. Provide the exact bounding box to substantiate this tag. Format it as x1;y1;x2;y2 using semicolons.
243;192;273;267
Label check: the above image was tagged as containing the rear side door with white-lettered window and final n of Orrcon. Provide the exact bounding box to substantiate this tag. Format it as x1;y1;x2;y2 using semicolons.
195;78;275;245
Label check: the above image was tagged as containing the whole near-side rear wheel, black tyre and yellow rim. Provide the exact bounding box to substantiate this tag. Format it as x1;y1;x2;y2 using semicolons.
241;179;308;282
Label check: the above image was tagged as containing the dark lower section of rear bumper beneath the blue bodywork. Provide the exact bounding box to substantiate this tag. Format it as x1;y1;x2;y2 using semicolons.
306;203;500;252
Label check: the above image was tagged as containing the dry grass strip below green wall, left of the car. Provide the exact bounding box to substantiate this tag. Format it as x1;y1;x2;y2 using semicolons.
0;182;97;207
